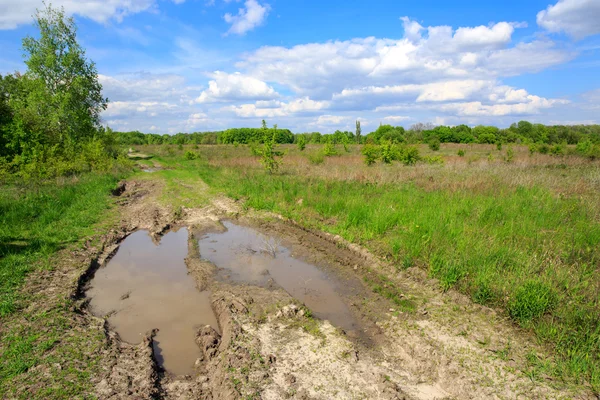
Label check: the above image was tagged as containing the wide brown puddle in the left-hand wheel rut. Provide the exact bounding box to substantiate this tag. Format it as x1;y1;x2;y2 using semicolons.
87;228;218;375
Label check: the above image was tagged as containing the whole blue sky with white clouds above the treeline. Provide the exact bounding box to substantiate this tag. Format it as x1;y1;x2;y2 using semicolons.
0;0;600;134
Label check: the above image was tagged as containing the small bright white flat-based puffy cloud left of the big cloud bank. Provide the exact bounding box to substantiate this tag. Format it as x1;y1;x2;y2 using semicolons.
196;71;279;103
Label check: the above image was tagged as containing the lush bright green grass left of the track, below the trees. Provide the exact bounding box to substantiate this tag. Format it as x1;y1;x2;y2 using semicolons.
0;174;122;317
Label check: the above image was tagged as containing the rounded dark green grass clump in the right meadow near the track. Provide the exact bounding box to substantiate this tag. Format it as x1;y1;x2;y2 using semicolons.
508;280;556;324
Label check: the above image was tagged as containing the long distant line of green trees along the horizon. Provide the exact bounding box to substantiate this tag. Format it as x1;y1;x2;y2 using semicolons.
116;121;600;145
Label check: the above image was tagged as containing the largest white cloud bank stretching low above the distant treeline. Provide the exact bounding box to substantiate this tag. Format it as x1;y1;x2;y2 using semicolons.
101;13;584;132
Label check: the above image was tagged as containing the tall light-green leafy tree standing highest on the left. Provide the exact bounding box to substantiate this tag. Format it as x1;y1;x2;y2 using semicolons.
16;5;108;146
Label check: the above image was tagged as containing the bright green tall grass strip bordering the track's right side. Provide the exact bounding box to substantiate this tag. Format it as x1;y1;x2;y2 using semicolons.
199;164;600;391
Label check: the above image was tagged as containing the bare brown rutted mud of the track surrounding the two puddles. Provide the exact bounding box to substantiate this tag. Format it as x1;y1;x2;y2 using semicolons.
24;181;593;399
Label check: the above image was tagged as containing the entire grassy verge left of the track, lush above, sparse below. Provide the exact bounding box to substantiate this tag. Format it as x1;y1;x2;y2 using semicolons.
0;175;124;399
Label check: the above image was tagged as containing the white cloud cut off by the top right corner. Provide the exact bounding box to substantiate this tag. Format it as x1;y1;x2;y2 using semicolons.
537;0;600;39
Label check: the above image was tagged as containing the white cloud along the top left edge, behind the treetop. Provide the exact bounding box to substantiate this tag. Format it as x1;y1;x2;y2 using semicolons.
0;0;185;29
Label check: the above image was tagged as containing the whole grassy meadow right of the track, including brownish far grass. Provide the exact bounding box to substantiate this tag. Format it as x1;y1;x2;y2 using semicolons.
142;145;600;392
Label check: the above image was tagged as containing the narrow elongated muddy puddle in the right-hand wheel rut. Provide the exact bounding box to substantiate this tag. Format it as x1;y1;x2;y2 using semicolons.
199;221;359;332
